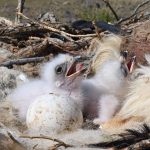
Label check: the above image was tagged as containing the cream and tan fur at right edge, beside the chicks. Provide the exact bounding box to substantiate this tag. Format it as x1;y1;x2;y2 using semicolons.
101;55;150;134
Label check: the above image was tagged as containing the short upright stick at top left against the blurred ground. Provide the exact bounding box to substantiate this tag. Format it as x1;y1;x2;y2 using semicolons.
15;0;25;23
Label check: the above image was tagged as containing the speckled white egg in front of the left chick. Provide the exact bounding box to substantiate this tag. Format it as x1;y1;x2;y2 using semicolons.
26;94;83;134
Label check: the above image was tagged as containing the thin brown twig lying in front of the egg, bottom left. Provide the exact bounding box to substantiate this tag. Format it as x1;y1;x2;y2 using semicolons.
20;135;73;148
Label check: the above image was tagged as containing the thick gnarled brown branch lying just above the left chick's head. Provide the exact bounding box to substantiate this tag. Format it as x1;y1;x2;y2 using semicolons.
15;37;92;58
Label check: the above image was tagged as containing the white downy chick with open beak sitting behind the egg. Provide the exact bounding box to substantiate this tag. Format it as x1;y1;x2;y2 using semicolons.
9;54;86;120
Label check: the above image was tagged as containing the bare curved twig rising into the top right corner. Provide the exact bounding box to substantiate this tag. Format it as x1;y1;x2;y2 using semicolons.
116;0;150;24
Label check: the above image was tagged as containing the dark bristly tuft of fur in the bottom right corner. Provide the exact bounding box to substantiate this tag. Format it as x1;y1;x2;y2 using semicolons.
89;124;150;150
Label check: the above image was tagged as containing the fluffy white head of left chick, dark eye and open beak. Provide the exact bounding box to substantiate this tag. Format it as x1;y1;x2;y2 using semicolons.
41;54;86;90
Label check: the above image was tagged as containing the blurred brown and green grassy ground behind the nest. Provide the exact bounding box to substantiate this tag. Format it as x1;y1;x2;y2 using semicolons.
0;0;150;23
